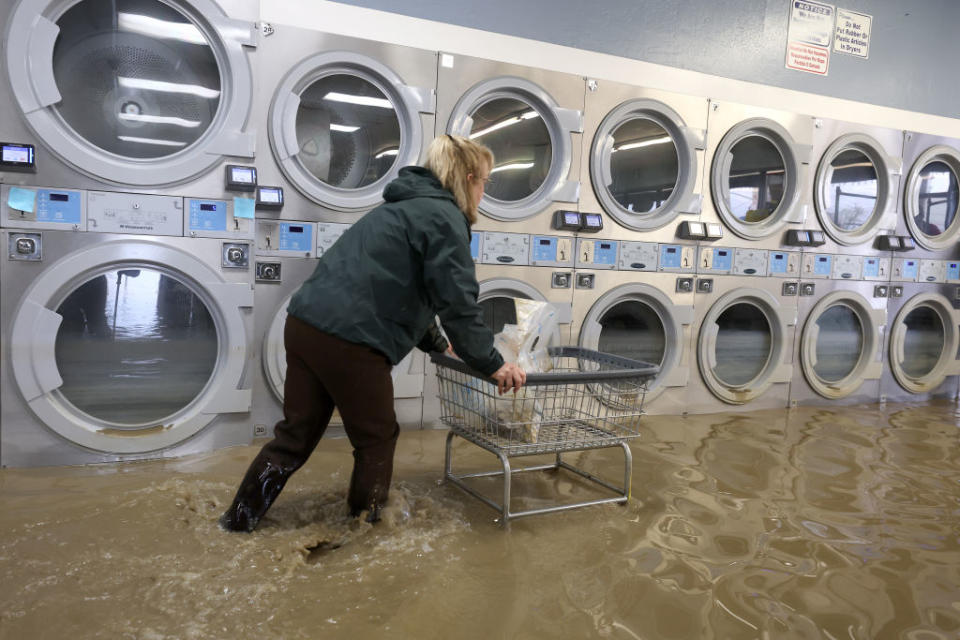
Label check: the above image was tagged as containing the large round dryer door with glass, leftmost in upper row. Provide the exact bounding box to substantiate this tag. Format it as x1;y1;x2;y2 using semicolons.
5;0;256;186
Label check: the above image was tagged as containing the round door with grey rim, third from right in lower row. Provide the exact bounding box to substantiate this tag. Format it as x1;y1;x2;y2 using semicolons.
697;287;796;404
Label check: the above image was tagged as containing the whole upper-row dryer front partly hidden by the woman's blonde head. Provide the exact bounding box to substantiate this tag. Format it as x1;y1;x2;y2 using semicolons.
437;53;584;234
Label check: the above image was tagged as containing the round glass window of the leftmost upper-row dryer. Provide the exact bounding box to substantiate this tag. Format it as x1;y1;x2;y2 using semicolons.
53;0;220;159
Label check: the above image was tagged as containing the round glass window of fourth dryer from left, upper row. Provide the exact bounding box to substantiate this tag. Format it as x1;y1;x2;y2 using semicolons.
607;118;680;213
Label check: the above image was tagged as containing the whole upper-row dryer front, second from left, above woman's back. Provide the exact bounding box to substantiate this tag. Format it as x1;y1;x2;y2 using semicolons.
254;23;437;223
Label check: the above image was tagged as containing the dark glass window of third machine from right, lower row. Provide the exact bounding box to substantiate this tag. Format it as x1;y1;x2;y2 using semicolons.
713;302;772;387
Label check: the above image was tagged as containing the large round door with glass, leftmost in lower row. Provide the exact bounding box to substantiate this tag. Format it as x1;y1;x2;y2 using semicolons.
10;238;253;453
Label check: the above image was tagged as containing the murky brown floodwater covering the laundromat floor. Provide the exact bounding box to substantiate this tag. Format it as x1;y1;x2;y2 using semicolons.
0;403;960;640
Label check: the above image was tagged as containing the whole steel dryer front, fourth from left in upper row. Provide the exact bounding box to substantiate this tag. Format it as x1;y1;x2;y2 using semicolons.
580;79;704;249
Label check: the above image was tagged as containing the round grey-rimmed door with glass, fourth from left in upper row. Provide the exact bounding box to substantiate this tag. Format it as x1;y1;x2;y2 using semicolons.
590;100;704;231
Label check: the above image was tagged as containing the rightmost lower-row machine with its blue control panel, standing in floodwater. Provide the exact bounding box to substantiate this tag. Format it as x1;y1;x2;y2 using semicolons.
880;258;960;402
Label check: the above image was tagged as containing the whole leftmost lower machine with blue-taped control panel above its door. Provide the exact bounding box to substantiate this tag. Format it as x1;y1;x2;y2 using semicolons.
0;186;253;466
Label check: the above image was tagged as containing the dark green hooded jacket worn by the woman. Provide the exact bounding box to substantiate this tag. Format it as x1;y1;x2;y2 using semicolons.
287;167;503;375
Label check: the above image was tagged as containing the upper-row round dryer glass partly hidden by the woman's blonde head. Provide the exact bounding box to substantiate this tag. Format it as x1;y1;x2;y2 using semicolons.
470;98;553;202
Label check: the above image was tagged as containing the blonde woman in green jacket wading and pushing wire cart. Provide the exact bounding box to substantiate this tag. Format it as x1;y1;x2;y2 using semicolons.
220;135;526;532
